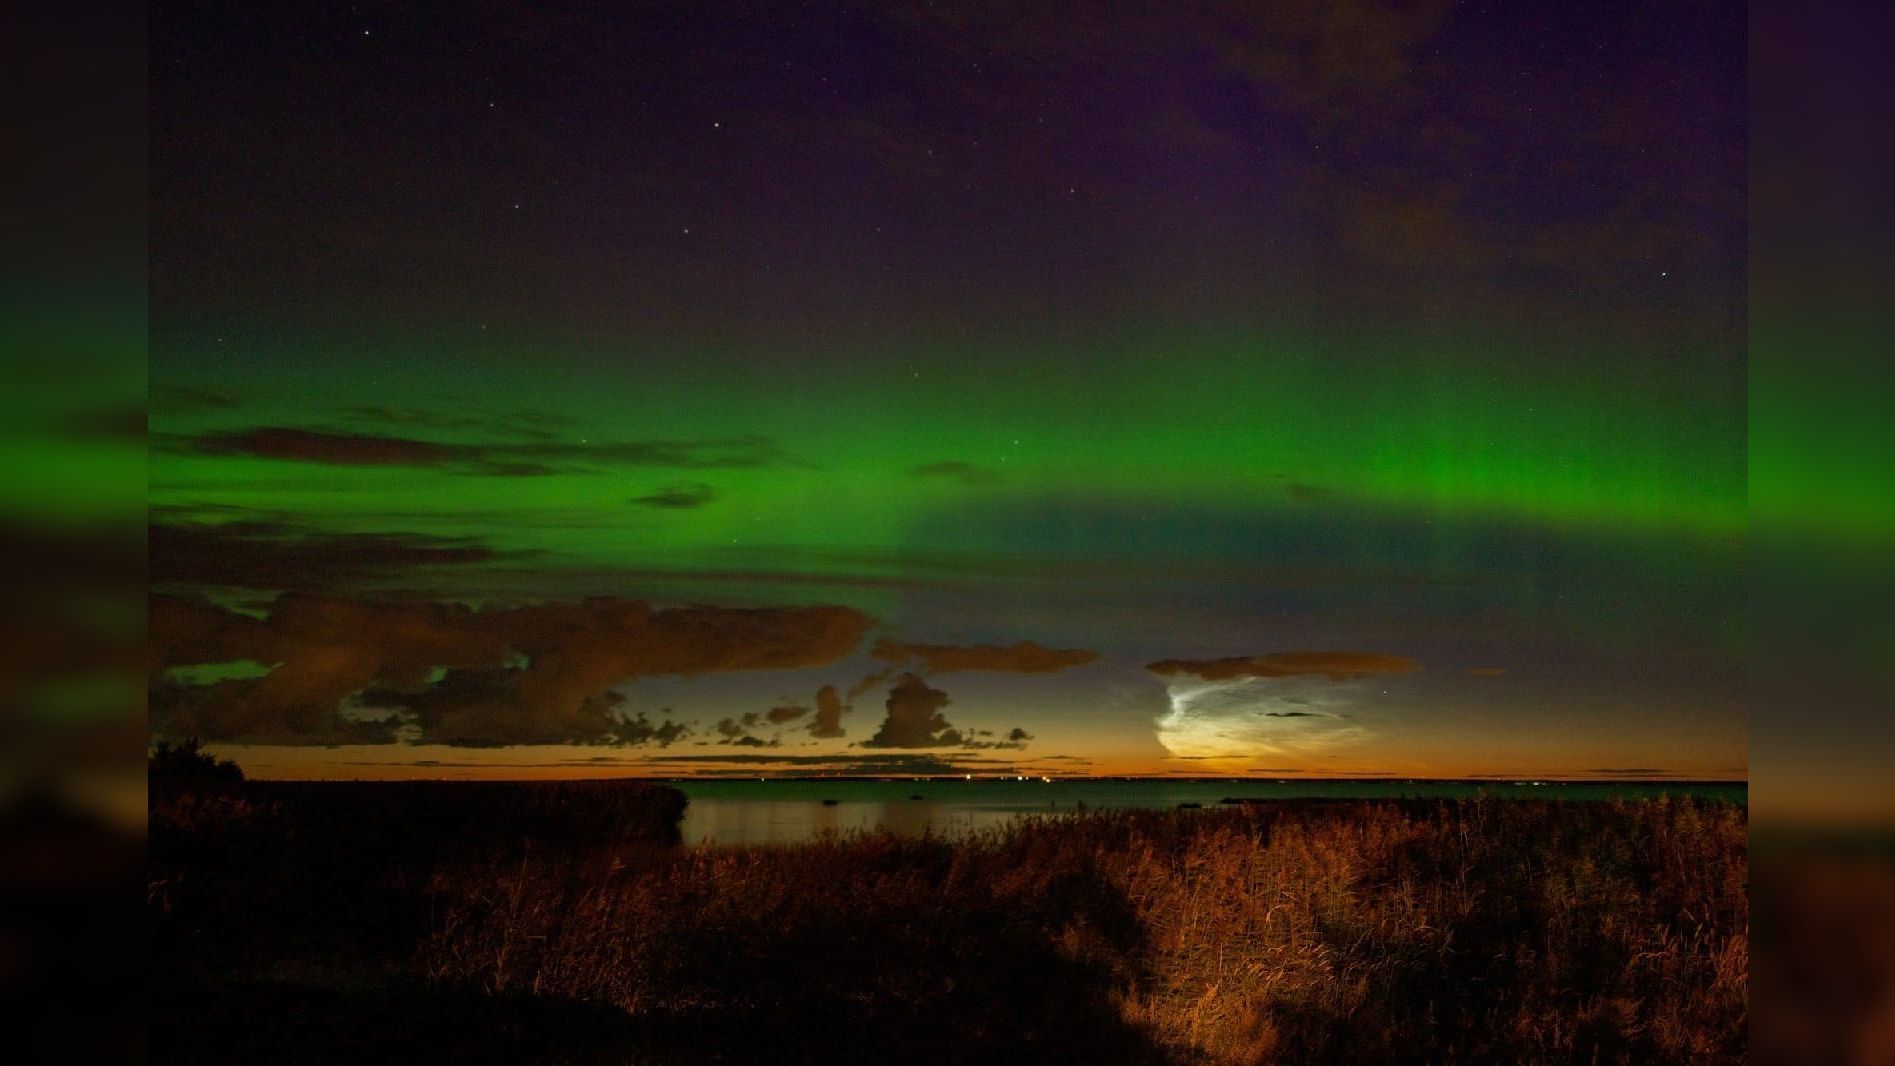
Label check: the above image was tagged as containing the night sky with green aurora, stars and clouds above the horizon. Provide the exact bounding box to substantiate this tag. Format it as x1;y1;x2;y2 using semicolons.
150;0;1747;778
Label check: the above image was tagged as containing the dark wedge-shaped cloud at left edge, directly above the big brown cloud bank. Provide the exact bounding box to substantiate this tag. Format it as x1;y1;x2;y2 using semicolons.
146;521;511;591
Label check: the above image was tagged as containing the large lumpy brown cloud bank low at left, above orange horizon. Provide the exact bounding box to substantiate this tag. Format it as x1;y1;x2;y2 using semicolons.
148;593;870;746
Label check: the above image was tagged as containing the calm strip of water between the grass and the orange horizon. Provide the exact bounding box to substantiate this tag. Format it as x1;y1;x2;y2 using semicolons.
675;780;1749;844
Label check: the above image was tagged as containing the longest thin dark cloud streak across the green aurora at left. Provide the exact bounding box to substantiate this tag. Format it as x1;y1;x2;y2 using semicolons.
176;426;790;477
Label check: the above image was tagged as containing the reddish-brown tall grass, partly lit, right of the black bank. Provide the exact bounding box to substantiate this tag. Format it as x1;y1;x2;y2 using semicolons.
417;799;1749;1062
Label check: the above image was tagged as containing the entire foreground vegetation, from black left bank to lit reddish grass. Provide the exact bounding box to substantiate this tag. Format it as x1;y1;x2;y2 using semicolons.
148;782;1749;1062
